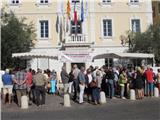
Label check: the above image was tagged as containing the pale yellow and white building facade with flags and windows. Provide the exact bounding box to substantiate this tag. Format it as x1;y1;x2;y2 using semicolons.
2;0;153;71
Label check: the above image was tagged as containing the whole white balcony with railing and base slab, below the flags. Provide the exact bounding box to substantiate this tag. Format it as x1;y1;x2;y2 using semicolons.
65;34;90;46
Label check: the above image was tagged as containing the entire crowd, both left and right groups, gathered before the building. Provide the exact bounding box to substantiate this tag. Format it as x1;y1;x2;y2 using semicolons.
2;64;160;107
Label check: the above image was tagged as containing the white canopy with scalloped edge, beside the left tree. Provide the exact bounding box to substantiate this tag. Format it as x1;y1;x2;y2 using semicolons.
12;52;58;60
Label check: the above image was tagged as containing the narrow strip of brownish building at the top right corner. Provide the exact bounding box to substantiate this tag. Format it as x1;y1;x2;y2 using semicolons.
152;0;160;25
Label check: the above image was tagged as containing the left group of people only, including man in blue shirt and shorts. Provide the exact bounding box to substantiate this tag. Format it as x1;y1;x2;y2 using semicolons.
2;69;57;107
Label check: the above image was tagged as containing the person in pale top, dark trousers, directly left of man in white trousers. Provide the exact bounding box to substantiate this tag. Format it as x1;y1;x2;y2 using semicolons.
73;64;80;101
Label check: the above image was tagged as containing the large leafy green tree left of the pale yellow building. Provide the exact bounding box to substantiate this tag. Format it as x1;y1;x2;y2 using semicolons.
1;9;35;69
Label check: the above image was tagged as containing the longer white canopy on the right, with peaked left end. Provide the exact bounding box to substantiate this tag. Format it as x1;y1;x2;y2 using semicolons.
93;53;154;59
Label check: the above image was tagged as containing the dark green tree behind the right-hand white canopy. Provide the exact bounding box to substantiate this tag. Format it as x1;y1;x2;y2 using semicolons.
129;24;160;63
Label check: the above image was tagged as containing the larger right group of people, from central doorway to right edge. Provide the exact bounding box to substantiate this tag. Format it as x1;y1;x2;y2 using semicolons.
61;65;160;104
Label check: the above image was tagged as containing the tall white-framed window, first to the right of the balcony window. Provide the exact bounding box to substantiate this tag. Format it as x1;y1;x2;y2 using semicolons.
103;19;112;37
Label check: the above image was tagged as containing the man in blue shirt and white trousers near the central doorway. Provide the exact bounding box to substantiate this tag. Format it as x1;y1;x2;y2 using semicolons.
78;66;86;104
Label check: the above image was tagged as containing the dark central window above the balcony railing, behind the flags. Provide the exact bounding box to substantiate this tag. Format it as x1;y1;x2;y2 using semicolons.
71;21;82;34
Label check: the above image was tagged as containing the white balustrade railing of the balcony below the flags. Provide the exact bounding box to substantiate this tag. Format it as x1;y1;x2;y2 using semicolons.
66;34;87;44
